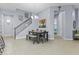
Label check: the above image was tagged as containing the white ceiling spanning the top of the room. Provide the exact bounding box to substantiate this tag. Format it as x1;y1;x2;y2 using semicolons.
0;3;79;13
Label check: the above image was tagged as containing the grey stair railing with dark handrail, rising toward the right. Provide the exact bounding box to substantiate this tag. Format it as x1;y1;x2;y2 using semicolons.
14;18;32;39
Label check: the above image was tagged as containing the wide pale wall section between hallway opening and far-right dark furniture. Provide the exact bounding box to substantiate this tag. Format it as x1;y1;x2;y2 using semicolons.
53;6;74;40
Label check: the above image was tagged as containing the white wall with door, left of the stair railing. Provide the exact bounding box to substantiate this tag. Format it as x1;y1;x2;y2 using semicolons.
0;10;25;36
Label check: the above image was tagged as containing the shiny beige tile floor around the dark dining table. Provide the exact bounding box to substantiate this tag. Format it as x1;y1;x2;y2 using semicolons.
3;38;79;55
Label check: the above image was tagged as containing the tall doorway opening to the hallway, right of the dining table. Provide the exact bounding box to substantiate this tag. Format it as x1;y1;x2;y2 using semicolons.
54;11;65;39
